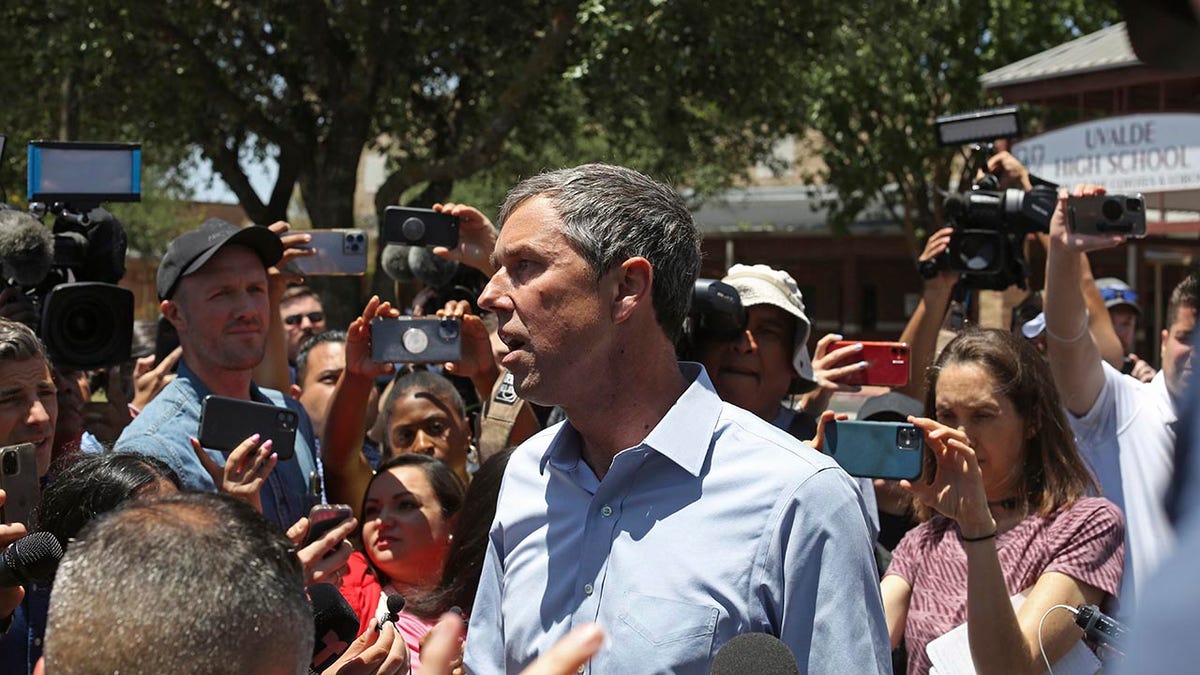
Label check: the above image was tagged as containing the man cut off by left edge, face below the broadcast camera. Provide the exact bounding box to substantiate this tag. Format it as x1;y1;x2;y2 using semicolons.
0;318;59;673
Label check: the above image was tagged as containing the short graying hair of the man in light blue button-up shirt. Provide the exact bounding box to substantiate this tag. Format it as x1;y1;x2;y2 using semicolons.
500;165;700;342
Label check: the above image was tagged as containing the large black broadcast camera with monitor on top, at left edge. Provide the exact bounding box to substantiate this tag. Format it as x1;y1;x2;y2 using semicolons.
0;136;142;370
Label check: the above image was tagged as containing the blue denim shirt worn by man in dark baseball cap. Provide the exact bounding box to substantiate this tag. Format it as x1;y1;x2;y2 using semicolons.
113;362;317;530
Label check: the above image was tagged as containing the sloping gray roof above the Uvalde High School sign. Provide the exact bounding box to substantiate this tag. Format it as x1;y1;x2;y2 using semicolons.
979;22;1141;89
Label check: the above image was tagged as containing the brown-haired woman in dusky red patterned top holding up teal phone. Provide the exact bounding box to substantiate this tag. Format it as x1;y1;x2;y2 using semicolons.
881;329;1124;675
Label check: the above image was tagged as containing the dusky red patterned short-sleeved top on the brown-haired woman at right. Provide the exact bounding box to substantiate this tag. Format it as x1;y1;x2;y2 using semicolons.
887;497;1124;675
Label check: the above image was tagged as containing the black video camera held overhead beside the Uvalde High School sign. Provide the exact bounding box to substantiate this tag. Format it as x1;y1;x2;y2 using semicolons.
920;106;1058;291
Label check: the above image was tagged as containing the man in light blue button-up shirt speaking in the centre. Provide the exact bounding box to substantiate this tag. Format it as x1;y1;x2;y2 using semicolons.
466;165;890;674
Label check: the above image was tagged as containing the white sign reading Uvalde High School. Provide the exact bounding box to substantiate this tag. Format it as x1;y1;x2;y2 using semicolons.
1013;114;1200;192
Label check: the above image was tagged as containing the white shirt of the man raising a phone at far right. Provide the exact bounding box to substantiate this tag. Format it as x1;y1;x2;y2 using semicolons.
1067;363;1176;613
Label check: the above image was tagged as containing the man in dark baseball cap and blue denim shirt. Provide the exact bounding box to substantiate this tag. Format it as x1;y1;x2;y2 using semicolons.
114;219;317;528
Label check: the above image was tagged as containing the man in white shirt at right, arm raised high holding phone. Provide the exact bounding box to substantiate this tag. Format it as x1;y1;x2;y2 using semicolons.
1045;185;1200;609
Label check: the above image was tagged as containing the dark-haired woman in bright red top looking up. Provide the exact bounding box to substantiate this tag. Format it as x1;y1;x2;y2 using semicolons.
341;454;466;670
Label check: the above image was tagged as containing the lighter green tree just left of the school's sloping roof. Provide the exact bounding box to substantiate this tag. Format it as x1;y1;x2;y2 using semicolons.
805;0;1117;259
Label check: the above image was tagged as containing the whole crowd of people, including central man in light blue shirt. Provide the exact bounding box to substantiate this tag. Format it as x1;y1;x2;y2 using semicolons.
0;154;1200;675
